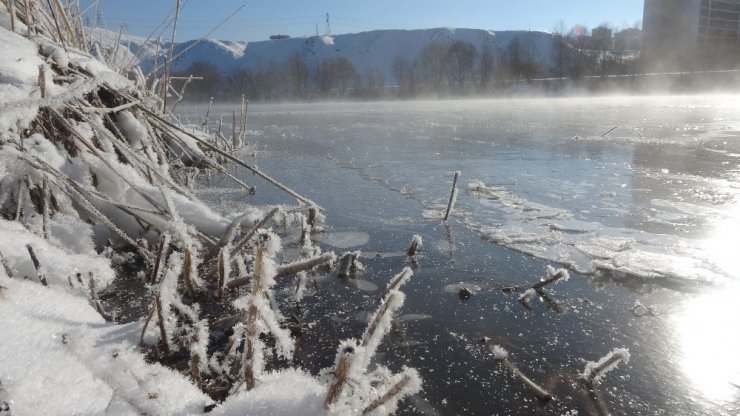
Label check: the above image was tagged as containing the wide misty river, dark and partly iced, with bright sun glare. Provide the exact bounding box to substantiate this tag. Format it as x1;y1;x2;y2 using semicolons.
186;96;740;415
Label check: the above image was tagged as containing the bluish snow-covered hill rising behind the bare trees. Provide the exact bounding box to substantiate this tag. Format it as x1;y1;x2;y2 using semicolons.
121;28;553;80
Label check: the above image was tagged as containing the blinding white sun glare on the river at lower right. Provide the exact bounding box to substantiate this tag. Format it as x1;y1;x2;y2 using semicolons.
675;283;740;403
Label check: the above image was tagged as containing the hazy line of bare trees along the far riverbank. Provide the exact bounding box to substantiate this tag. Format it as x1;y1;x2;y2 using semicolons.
177;24;652;101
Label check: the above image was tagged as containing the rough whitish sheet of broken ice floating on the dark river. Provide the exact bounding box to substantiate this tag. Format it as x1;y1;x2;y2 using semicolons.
465;182;729;282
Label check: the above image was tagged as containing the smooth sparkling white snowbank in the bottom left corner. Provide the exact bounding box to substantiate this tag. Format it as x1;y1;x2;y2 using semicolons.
0;274;209;415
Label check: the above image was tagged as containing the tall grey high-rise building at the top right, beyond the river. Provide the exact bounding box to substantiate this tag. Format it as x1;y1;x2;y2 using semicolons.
642;0;740;71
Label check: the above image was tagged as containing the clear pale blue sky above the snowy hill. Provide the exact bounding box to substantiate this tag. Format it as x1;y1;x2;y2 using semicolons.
85;0;643;41
